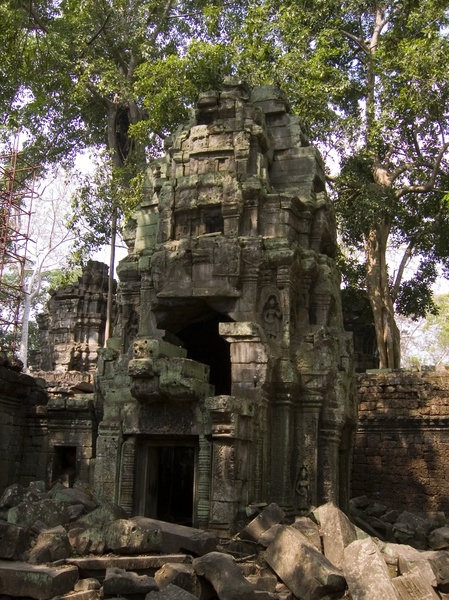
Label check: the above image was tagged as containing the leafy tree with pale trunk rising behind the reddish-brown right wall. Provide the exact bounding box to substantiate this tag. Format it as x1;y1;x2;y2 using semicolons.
229;0;449;368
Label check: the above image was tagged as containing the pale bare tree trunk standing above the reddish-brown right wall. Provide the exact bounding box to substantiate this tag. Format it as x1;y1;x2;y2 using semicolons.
364;219;401;369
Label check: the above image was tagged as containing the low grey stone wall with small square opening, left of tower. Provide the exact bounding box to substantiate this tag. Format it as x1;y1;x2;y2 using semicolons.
0;366;99;494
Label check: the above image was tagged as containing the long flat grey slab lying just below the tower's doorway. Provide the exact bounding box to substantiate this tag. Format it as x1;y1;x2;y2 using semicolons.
130;517;218;556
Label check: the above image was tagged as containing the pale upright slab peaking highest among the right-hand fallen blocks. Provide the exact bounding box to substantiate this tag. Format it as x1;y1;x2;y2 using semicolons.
314;502;357;569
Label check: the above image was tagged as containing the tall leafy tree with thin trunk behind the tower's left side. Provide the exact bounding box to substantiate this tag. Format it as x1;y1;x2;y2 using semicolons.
0;0;239;342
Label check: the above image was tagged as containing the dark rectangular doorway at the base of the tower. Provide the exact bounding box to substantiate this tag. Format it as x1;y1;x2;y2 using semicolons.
134;439;198;527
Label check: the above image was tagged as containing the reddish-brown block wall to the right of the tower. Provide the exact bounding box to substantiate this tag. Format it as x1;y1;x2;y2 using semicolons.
351;371;449;513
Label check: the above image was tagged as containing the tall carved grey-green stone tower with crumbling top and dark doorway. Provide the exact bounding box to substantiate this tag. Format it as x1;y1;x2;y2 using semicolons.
95;82;356;530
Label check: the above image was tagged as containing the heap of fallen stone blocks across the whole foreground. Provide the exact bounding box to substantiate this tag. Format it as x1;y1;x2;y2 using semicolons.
0;482;449;600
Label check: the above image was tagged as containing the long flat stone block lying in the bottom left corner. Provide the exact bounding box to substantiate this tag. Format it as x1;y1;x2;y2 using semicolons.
0;560;78;600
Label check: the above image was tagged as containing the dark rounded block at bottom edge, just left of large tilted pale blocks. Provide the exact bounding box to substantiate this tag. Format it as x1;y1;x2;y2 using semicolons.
192;552;255;600
